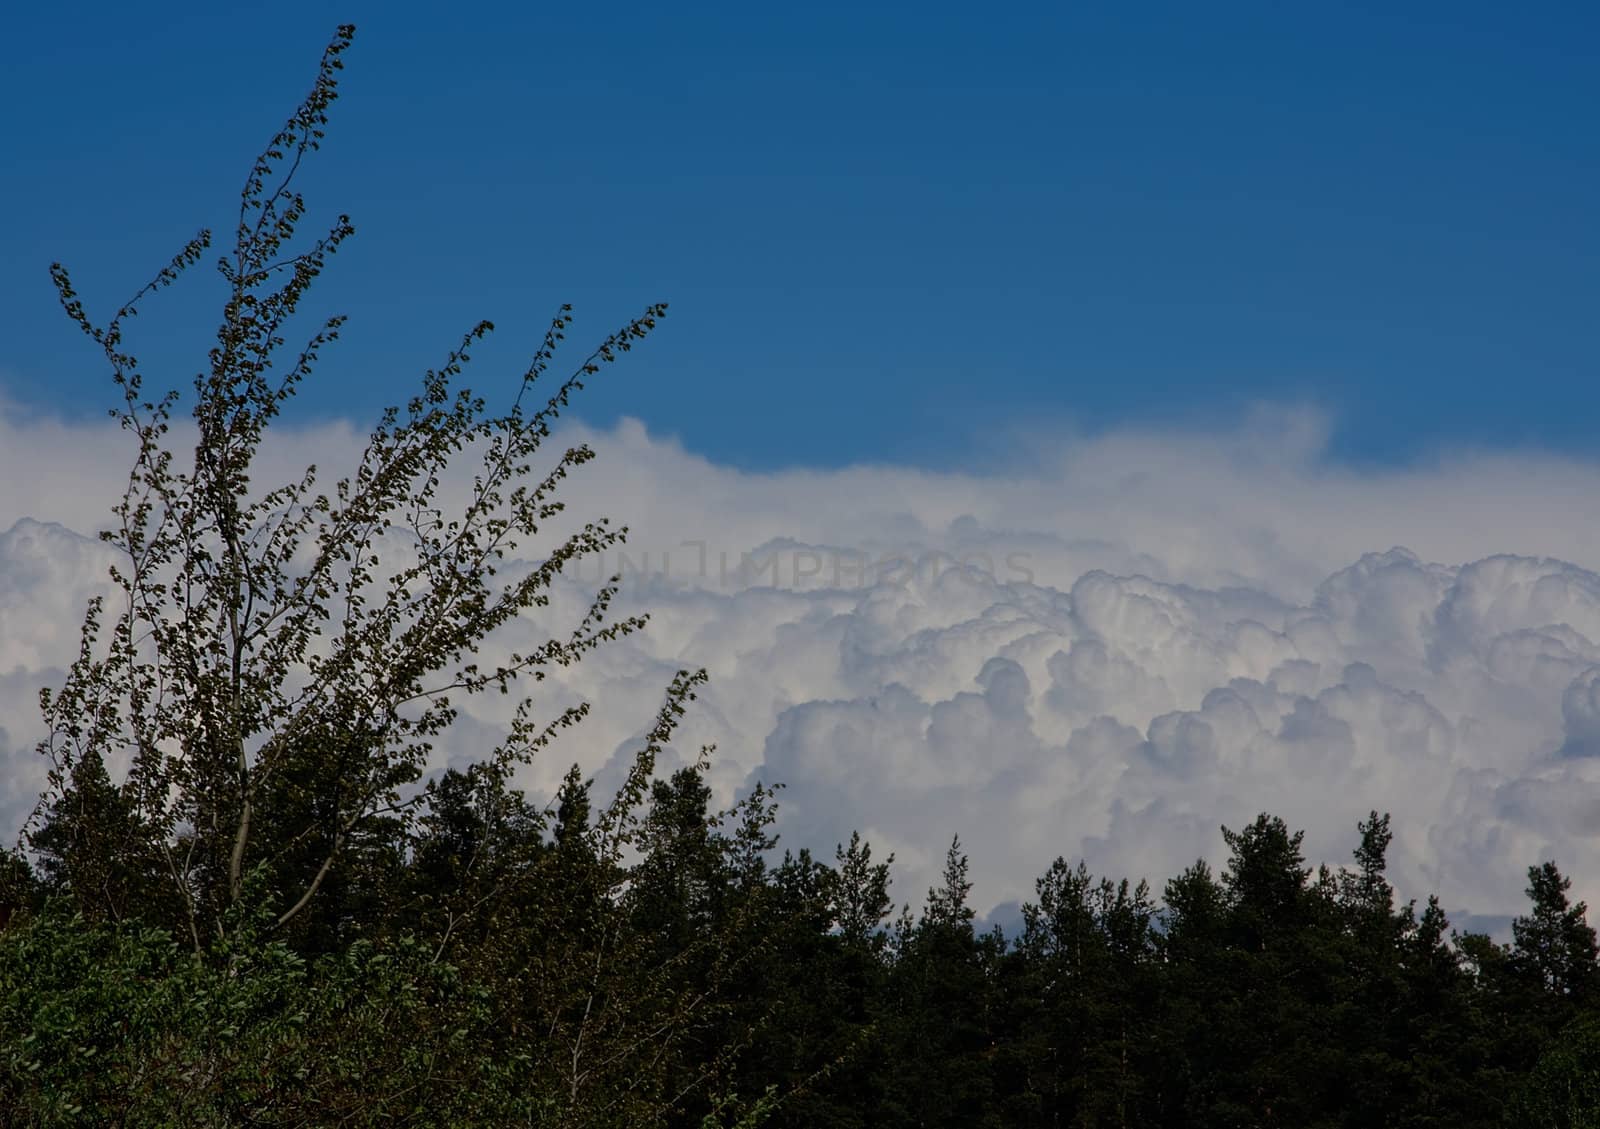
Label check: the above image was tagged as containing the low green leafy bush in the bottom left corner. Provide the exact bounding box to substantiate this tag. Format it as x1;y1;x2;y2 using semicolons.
0;913;499;1126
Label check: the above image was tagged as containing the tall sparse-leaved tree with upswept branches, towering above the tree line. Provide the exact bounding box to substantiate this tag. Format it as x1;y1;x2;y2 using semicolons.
29;27;666;951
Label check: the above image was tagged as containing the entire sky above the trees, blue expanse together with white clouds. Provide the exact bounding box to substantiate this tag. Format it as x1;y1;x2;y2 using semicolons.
9;0;1600;924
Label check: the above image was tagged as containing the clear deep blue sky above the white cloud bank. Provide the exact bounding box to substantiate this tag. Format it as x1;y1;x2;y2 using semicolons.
0;3;1600;469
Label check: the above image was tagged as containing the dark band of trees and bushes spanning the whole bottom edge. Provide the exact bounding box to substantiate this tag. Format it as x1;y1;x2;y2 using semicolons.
0;766;1600;1127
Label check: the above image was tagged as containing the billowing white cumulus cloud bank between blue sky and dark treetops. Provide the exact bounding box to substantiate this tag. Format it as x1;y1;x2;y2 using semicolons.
0;399;1600;918
